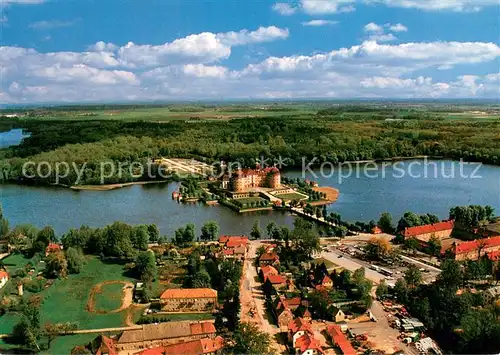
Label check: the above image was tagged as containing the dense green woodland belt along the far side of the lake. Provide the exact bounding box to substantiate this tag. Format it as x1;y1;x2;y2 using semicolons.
0;107;500;185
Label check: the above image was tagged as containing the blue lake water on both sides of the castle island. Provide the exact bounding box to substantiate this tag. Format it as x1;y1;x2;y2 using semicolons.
0;161;500;236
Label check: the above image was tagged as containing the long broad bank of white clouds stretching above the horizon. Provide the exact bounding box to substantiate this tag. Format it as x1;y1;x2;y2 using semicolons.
0;32;500;103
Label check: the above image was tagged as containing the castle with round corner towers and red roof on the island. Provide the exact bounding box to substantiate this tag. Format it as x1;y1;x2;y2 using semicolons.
229;167;281;192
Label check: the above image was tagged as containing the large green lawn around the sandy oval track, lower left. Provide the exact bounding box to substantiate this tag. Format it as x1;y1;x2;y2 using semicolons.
40;257;133;329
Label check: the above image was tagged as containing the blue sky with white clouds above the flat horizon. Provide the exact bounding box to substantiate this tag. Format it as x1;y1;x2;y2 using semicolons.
0;0;500;104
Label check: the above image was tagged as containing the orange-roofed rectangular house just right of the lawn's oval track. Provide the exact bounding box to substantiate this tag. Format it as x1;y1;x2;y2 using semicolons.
160;288;217;312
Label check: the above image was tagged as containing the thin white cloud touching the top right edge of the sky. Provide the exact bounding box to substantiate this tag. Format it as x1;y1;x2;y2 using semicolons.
364;0;499;12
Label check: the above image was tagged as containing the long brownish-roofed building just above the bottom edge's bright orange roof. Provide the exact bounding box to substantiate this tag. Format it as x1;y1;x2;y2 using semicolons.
114;321;216;355
